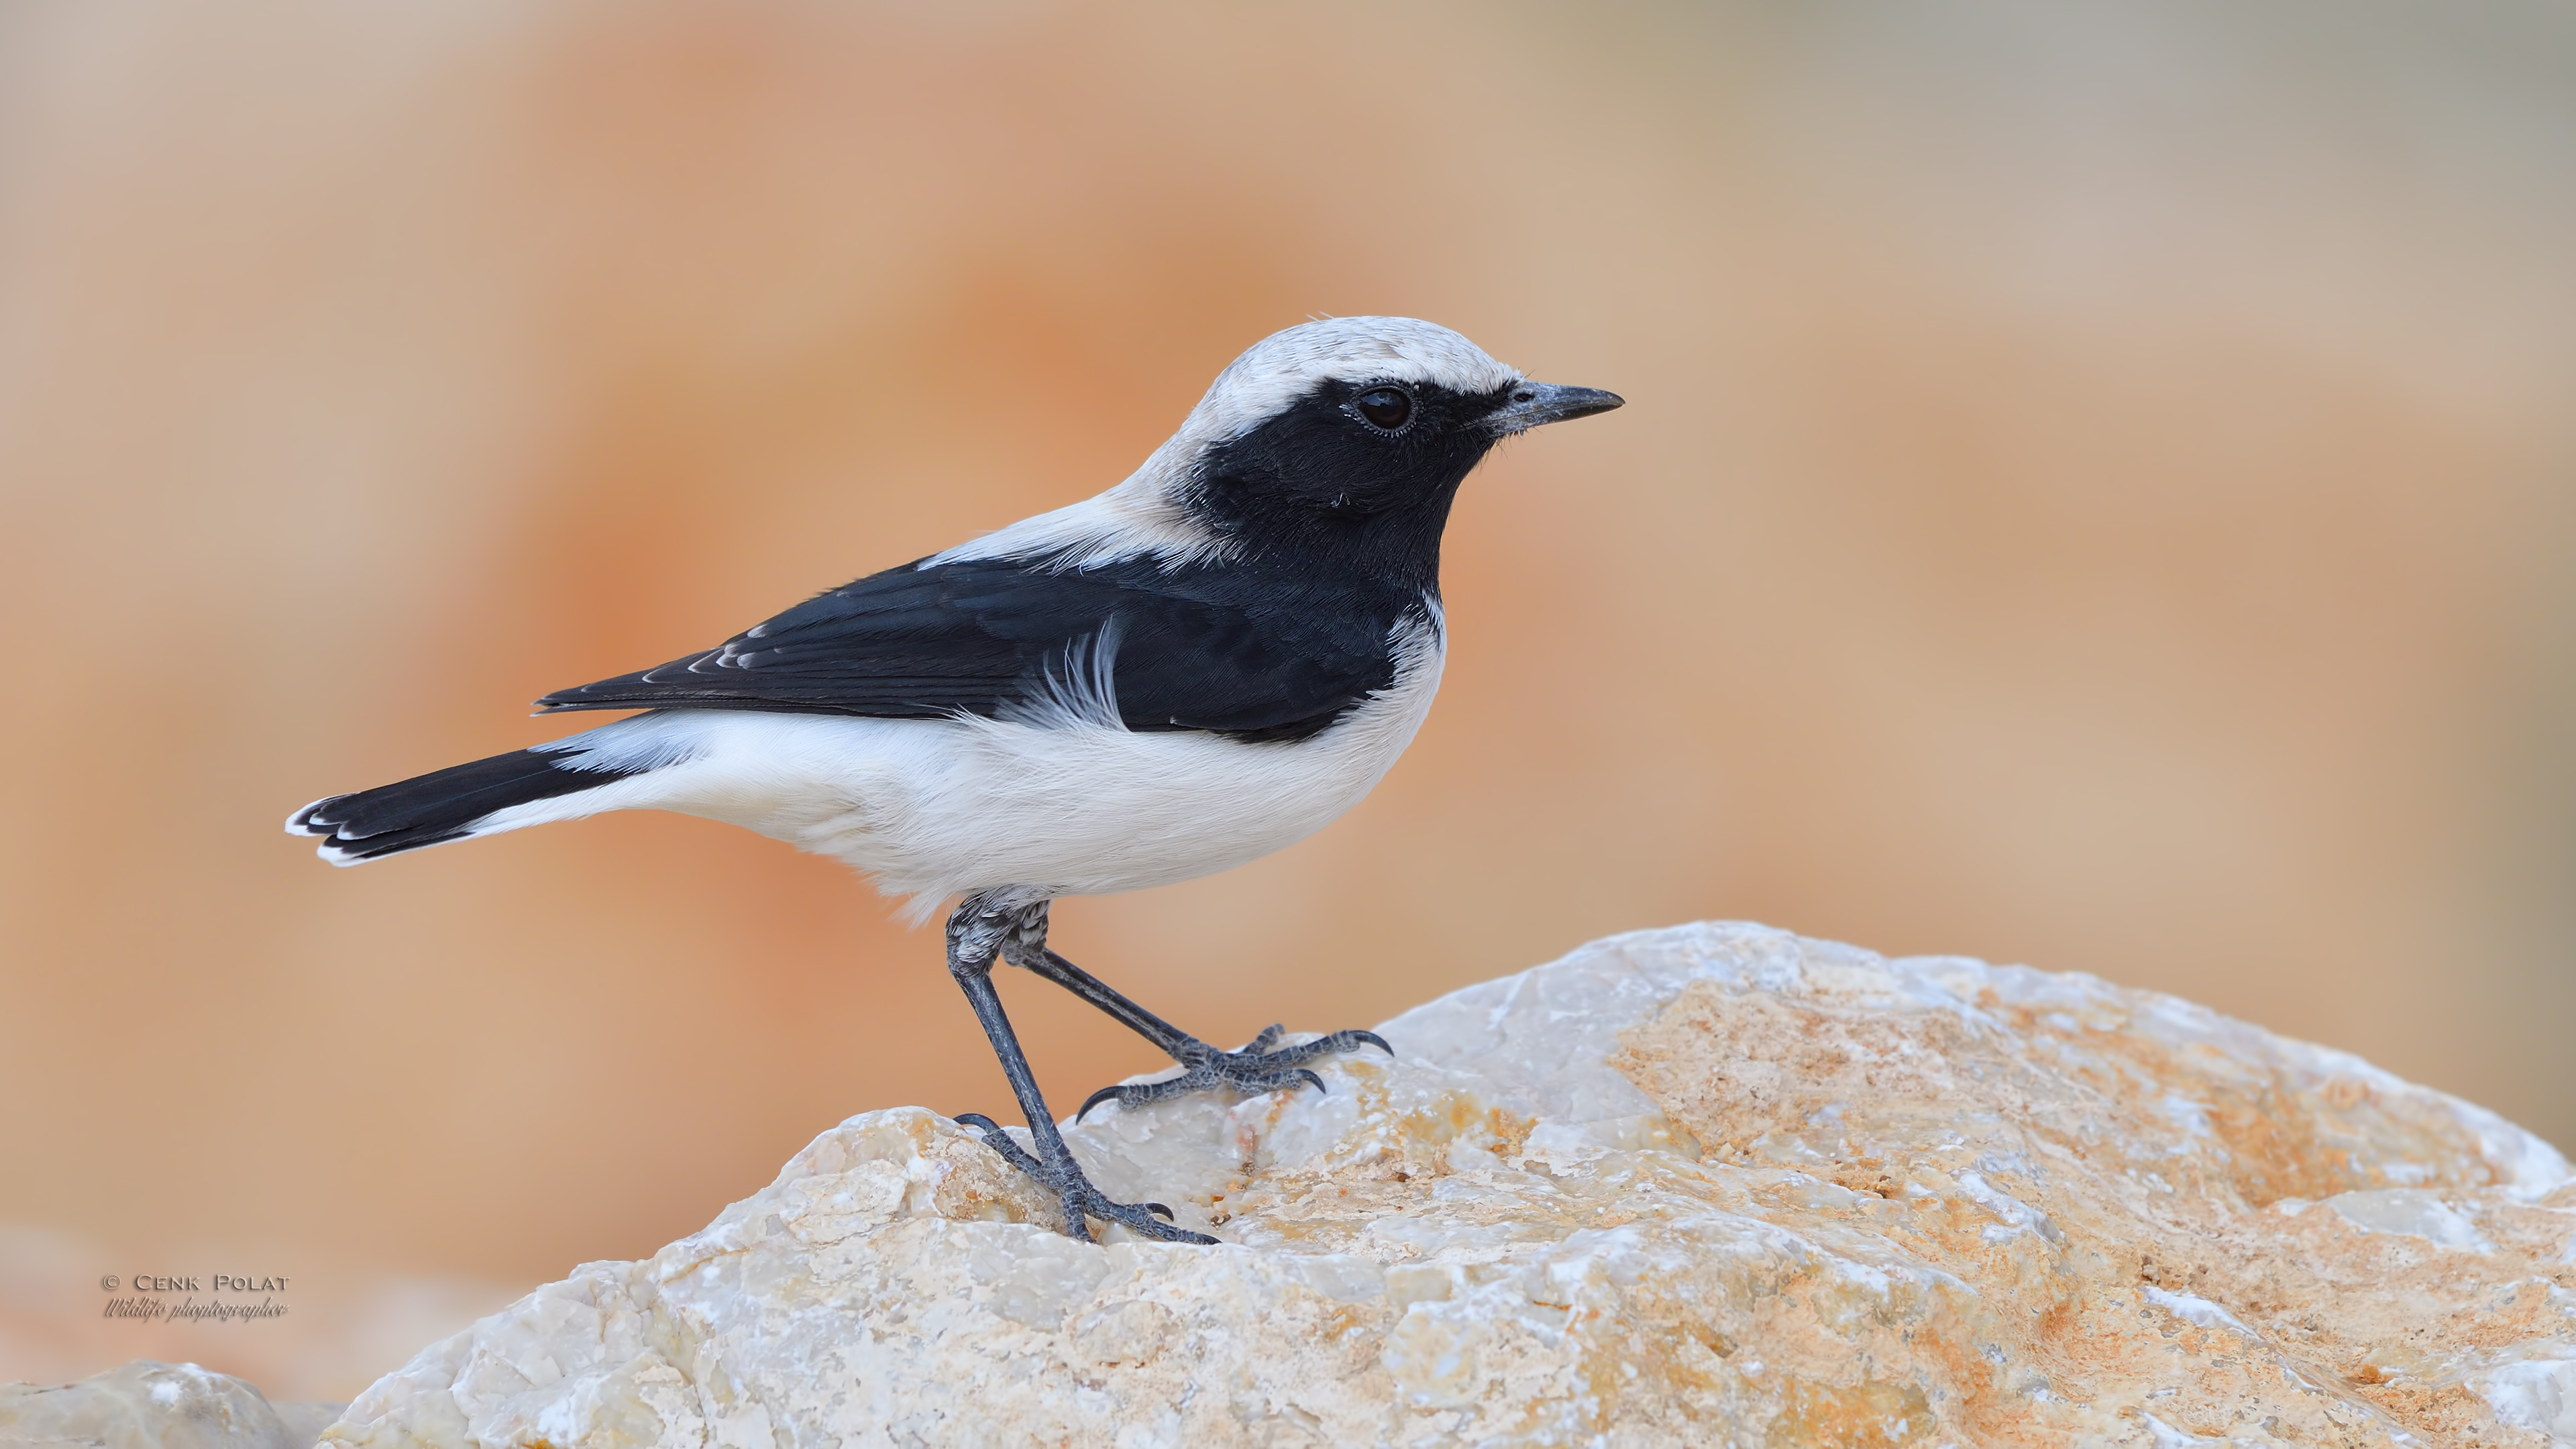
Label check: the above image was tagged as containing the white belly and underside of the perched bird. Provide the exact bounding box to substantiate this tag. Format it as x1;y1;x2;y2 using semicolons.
490;608;1442;918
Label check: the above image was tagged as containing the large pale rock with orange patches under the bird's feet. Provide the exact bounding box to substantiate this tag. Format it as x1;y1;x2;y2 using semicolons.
325;926;2576;1449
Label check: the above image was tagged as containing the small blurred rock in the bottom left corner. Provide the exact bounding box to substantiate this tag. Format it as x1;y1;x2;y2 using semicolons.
0;1358;340;1449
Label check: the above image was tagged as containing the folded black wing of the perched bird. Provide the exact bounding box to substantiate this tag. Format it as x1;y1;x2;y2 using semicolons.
539;549;1422;740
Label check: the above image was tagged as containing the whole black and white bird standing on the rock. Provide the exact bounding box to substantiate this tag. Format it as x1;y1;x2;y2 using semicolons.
286;317;1620;1243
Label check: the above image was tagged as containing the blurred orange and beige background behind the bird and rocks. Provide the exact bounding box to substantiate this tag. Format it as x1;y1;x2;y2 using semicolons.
0;0;2576;1397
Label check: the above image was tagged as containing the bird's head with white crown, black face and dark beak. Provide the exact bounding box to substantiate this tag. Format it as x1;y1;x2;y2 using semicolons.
1175;317;1620;551
